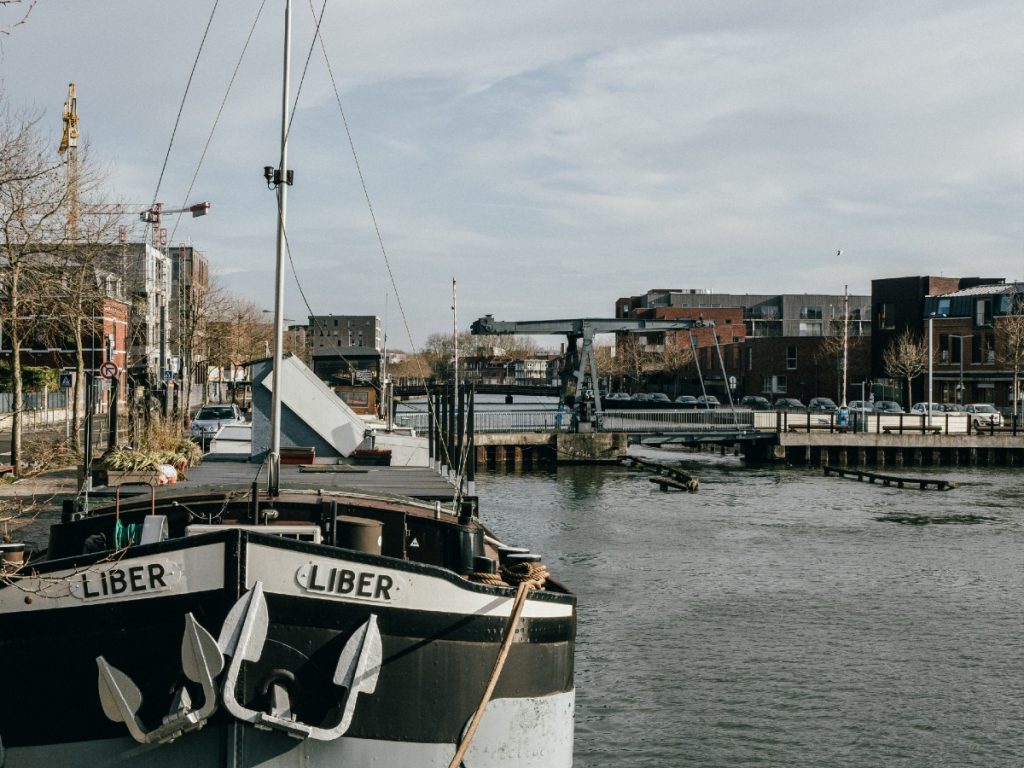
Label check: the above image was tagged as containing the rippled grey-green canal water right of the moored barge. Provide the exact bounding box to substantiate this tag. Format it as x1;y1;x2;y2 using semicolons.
477;451;1024;768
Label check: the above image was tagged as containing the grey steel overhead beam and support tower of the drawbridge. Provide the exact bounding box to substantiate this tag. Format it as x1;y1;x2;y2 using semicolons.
470;314;715;417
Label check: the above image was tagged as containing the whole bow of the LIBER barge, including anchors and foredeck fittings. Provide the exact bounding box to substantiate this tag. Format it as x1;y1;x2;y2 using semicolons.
0;494;575;768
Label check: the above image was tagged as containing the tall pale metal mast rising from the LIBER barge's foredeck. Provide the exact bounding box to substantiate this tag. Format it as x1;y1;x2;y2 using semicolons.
264;0;292;496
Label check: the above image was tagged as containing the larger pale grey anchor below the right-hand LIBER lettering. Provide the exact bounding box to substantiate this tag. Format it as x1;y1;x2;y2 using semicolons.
217;582;383;741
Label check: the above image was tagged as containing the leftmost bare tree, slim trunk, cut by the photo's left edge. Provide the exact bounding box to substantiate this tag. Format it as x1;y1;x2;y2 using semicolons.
0;104;68;474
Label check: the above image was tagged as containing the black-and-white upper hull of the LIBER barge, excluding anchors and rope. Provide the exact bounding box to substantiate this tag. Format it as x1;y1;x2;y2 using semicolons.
0;529;575;764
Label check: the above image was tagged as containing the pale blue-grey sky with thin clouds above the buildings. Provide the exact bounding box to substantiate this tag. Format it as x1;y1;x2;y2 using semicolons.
0;0;1024;350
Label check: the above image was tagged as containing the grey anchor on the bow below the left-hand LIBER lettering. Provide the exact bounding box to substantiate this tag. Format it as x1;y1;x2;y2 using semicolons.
96;613;224;744
